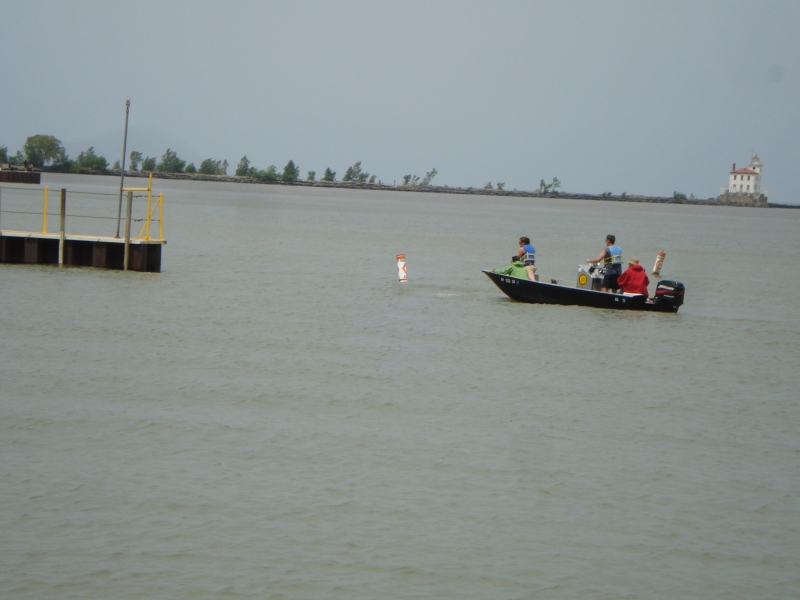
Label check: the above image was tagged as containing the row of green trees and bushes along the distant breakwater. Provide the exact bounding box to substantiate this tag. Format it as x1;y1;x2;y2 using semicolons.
0;135;561;193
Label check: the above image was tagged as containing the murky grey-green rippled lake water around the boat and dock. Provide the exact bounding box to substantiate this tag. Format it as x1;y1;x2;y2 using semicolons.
0;177;800;599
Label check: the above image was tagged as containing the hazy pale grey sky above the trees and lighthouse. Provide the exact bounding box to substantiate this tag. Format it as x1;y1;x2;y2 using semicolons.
0;0;800;203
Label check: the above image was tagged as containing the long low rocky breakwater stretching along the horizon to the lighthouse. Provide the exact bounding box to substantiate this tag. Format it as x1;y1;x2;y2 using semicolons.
36;168;800;208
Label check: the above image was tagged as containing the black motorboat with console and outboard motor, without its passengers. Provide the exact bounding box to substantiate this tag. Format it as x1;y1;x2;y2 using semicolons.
484;264;686;312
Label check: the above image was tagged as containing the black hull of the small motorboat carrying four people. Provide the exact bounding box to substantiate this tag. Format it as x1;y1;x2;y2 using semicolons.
484;271;678;312
